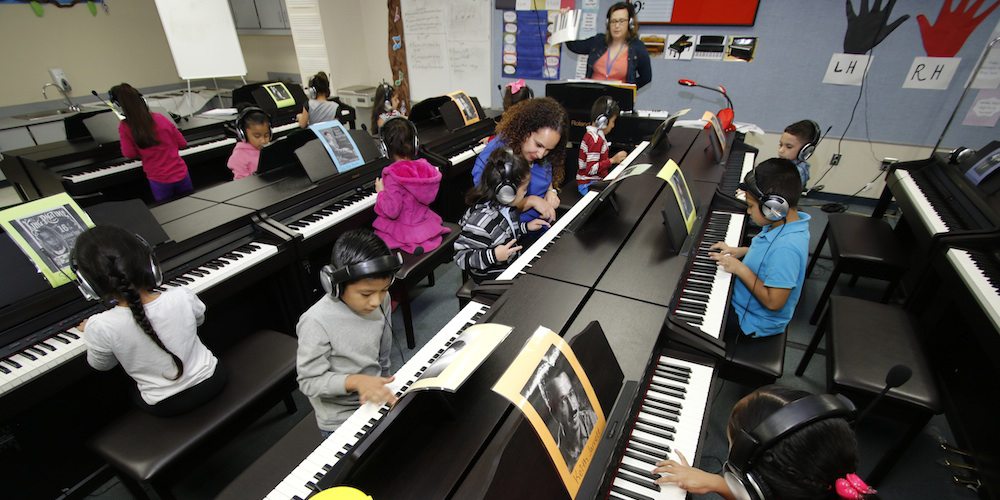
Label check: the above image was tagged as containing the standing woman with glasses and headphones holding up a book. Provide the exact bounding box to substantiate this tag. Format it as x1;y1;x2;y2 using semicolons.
566;2;653;89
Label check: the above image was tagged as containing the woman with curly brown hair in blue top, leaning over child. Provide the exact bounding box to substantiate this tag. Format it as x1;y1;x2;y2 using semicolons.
472;97;568;222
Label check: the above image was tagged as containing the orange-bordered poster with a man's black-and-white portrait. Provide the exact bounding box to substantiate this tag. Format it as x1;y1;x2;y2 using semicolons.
493;326;606;498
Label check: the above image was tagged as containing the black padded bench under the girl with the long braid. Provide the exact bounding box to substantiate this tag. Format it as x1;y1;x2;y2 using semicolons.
90;330;298;499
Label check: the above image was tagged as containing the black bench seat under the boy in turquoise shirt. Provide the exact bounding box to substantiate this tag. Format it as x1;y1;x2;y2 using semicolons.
722;332;788;386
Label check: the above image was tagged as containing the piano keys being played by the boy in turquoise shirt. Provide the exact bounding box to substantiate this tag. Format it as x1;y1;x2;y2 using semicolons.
673;211;746;338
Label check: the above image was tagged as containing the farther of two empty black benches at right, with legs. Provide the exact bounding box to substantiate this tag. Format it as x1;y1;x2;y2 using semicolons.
806;214;908;325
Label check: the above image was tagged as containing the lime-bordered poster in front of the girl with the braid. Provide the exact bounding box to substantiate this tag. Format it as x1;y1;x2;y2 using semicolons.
0;193;94;288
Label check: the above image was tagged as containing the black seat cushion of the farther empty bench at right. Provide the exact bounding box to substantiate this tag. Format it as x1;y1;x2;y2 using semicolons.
816;214;908;272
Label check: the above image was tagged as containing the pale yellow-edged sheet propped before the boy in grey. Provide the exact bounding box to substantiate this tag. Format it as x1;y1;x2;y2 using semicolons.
406;323;514;394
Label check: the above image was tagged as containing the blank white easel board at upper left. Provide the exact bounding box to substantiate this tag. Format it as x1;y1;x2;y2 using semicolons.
156;0;247;80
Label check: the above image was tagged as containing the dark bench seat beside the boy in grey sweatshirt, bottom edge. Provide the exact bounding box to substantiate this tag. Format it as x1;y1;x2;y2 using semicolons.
215;411;323;500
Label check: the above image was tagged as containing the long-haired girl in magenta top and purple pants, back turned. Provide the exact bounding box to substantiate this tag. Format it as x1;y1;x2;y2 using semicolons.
108;83;194;201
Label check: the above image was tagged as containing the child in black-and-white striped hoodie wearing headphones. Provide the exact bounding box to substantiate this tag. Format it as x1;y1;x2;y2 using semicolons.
455;147;549;283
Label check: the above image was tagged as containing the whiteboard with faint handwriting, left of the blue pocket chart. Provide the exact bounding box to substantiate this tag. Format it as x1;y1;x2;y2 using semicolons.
400;0;493;108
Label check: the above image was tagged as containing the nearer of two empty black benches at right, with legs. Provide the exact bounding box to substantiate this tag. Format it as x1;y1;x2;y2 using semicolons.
795;296;942;486
